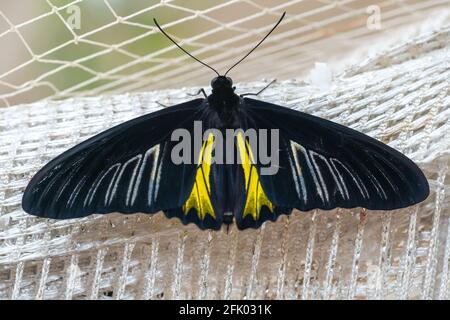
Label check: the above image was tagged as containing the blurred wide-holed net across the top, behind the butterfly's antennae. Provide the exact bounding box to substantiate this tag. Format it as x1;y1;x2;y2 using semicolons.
0;0;448;106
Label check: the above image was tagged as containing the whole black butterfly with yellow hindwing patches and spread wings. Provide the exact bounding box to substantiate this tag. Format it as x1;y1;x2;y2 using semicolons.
22;14;429;229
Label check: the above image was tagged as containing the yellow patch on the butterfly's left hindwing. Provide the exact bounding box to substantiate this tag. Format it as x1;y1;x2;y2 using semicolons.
182;133;216;220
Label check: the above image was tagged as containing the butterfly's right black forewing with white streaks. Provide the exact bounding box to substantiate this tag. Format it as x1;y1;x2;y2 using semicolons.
235;98;429;228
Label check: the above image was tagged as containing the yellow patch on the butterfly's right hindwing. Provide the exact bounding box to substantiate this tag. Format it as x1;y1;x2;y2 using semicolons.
237;133;273;221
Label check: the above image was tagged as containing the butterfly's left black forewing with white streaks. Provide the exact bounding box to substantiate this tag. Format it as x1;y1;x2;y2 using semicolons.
22;99;220;226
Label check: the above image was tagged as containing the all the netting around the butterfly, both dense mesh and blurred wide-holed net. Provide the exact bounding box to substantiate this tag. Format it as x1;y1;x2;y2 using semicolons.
0;1;450;299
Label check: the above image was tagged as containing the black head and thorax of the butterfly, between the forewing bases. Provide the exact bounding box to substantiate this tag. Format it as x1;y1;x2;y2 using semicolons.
208;76;240;128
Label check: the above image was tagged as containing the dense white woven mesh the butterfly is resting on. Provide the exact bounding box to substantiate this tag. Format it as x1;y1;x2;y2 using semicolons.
0;20;450;299
